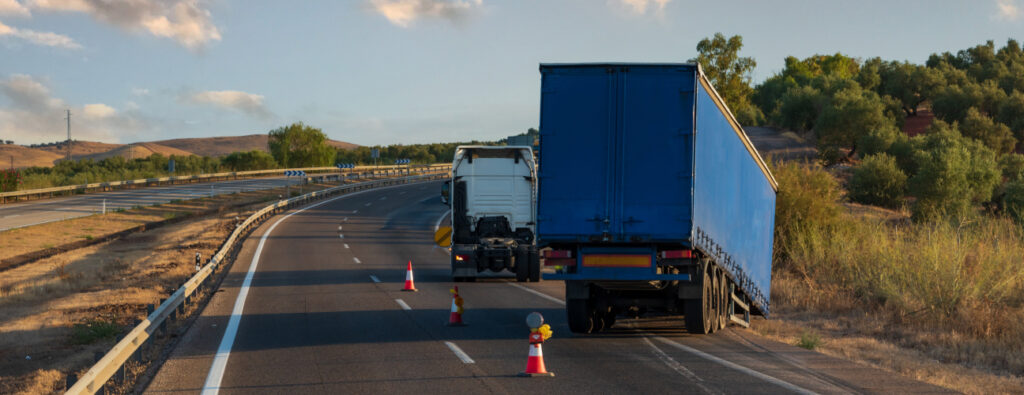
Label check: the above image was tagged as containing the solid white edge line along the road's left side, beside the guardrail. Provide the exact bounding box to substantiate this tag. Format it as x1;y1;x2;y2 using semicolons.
202;185;415;395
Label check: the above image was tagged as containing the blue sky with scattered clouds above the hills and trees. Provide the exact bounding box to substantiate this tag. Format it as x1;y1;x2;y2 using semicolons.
0;0;1024;144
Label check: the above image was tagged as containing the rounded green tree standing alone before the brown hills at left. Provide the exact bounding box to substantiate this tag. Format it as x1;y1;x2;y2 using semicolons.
267;122;336;168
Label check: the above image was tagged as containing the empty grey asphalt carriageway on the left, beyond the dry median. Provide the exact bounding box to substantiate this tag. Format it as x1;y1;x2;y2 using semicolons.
0;177;299;230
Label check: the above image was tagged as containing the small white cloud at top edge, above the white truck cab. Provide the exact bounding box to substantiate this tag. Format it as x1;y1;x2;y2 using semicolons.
370;0;483;28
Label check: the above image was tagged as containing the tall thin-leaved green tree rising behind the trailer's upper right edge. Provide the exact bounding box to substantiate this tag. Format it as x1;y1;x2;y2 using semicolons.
696;33;764;125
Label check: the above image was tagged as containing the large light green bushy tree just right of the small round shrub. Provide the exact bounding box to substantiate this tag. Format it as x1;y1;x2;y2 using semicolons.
908;121;1000;220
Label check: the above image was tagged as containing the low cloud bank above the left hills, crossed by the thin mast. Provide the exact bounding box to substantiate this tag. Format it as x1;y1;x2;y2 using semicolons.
0;74;150;144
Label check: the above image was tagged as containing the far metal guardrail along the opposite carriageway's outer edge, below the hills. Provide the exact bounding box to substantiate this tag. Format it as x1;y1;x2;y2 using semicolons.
0;164;452;204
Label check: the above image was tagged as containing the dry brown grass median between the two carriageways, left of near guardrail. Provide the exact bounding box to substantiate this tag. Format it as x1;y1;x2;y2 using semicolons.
0;180;348;393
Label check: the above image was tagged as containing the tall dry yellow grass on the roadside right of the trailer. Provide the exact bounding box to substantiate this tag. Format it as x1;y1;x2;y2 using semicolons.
770;159;1024;393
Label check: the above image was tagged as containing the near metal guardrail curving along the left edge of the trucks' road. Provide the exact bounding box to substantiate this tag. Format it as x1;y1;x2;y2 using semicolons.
67;165;452;394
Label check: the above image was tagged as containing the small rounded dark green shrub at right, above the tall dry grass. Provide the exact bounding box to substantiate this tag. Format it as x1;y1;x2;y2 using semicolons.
850;153;906;208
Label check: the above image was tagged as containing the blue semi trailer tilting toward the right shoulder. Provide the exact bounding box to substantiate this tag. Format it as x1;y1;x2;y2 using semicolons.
537;63;778;334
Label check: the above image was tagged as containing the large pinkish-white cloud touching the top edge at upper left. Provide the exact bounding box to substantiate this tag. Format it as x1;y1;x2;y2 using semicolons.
28;0;220;50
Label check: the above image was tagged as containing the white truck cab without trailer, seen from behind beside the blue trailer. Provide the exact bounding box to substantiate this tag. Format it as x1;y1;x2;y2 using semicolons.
451;145;541;281
